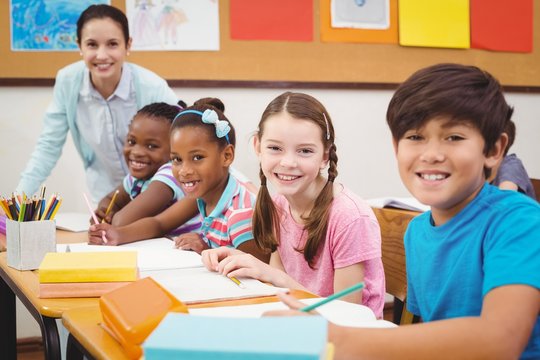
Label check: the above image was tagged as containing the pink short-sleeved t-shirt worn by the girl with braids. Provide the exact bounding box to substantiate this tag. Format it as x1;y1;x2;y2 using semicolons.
274;188;385;318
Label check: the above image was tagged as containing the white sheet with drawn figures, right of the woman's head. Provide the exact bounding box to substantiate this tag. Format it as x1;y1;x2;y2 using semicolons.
126;0;219;51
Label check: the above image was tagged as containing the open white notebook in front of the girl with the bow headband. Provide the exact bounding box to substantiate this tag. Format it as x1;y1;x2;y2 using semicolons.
56;238;203;277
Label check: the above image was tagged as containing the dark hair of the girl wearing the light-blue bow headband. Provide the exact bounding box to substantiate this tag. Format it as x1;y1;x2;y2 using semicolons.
171;97;236;148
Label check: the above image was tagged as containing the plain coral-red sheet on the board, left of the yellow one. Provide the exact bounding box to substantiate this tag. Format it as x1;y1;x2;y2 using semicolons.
230;0;313;41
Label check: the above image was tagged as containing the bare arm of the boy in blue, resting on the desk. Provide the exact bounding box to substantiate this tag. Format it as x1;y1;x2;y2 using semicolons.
329;285;540;360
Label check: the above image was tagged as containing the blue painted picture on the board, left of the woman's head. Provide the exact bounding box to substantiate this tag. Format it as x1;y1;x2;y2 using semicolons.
10;0;110;51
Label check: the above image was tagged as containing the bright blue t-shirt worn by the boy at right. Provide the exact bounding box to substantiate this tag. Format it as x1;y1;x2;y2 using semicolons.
404;184;540;359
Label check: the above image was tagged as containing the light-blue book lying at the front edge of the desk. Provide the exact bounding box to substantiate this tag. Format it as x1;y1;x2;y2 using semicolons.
143;313;328;360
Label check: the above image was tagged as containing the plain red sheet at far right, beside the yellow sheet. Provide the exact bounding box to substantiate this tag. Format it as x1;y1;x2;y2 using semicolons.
471;0;533;52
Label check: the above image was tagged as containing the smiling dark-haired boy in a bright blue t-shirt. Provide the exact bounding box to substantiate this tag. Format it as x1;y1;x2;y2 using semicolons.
274;64;540;359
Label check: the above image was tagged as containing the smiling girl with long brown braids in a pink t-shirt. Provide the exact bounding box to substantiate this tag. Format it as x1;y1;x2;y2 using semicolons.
203;92;385;317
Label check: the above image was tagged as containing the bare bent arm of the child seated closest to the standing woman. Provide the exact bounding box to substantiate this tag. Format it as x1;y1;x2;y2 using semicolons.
112;181;174;226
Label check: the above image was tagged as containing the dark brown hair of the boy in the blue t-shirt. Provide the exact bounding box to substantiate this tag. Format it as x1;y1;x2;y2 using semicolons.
386;64;514;155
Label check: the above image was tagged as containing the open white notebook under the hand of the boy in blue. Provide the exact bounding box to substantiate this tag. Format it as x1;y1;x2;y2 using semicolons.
189;298;397;328
